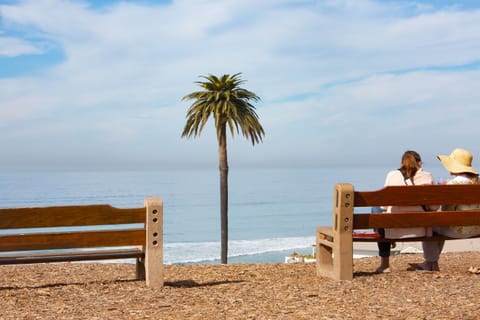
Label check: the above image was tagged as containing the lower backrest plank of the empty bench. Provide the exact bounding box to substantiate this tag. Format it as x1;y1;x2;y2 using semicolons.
0;229;146;251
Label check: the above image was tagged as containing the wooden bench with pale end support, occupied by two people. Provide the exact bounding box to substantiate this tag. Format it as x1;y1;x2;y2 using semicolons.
316;183;480;280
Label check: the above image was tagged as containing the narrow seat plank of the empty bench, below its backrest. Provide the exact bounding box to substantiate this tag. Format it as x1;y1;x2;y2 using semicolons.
0;248;145;265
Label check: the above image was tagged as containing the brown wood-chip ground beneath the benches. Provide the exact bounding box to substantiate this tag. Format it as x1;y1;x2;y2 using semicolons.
0;248;480;320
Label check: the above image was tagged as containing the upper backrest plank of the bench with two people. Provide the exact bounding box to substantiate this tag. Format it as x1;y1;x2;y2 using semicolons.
354;184;480;207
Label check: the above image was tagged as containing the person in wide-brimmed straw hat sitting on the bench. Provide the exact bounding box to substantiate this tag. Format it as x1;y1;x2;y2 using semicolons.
411;148;480;271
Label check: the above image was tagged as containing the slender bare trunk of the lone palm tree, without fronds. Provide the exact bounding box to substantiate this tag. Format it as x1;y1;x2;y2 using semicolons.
218;125;228;264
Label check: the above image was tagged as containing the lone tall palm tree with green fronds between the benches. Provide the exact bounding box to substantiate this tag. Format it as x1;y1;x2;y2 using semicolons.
182;73;265;264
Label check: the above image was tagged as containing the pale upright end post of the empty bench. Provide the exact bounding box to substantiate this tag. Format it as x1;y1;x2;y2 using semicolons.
144;198;163;288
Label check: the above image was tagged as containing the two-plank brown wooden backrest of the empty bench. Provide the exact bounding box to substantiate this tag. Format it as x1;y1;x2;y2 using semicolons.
0;205;146;252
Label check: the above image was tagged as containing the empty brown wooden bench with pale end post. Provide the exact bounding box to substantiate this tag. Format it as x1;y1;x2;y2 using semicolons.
0;198;163;288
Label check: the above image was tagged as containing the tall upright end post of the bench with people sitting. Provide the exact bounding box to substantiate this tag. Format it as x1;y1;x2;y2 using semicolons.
333;183;355;280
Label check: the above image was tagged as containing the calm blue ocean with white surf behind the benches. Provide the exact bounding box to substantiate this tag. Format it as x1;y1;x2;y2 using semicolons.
0;167;446;264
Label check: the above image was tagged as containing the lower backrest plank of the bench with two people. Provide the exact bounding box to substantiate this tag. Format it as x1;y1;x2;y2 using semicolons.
353;210;480;229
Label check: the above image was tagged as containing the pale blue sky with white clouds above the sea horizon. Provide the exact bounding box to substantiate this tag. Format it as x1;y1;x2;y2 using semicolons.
0;0;480;169
